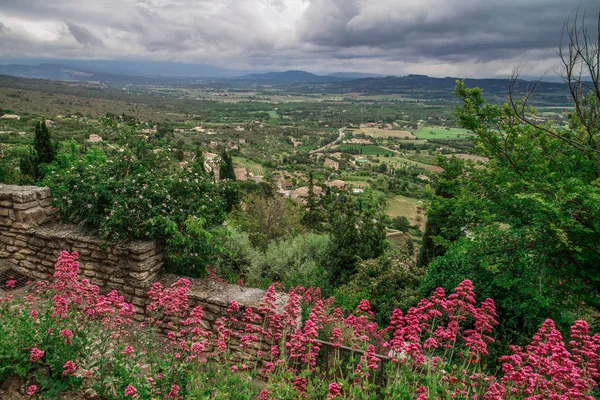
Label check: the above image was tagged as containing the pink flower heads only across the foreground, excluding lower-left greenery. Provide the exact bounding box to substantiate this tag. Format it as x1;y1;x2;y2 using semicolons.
11;252;600;400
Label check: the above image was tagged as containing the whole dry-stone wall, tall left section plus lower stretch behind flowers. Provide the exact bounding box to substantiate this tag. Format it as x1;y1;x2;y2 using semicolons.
0;185;287;332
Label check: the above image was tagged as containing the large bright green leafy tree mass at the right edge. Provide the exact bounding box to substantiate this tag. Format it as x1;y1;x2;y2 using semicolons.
422;82;600;342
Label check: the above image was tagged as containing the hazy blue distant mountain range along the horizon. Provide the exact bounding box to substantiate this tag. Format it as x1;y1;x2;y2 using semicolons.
0;61;568;105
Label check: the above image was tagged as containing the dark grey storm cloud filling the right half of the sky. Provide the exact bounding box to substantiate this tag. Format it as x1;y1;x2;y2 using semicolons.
299;0;600;62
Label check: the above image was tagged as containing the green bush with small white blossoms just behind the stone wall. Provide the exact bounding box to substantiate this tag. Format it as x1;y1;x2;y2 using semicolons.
45;148;236;276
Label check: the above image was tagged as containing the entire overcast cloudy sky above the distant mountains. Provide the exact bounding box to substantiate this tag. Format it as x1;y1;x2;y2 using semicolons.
0;0;600;77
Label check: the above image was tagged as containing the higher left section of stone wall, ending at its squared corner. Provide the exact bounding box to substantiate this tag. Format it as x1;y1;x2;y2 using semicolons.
0;185;163;313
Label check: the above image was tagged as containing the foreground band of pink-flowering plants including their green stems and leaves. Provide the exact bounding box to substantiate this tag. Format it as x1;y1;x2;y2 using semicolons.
0;252;600;400
